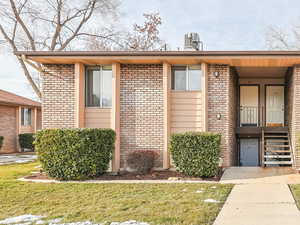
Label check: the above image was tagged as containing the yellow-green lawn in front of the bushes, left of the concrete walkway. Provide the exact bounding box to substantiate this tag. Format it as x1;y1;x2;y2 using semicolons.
0;163;232;225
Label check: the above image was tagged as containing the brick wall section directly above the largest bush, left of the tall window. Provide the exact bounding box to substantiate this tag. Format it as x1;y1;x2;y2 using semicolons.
42;64;75;128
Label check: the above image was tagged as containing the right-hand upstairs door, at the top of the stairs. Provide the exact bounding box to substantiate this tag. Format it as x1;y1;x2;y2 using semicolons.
266;86;284;127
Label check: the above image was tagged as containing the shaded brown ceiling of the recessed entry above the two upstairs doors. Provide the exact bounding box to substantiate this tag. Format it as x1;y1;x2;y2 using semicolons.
236;67;288;78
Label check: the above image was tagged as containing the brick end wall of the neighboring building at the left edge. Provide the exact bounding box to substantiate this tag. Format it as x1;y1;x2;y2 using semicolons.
0;106;17;153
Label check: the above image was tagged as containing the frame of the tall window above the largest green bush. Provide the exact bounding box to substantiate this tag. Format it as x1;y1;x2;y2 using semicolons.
84;64;113;109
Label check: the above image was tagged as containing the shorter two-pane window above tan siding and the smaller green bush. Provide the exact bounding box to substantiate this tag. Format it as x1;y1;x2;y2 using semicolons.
172;65;202;91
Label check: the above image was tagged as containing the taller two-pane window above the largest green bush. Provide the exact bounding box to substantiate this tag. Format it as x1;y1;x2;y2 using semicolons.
85;66;112;108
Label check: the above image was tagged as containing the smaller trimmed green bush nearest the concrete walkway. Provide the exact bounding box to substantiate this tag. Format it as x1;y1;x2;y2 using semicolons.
170;132;221;177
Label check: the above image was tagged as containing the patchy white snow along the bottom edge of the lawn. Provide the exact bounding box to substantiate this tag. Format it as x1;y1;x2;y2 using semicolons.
0;214;149;225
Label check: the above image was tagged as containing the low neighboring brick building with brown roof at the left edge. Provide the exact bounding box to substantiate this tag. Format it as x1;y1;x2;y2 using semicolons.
0;90;42;154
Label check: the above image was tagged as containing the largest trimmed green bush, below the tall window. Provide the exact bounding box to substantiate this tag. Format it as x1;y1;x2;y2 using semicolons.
34;129;115;180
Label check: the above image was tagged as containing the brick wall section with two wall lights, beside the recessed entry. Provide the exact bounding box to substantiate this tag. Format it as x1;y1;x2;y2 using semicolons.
208;65;236;167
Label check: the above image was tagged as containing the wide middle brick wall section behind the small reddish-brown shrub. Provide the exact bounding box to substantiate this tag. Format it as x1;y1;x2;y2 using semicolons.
120;64;163;167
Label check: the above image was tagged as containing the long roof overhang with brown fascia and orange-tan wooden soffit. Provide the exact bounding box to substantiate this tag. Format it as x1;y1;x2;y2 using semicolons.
15;51;300;67
